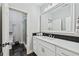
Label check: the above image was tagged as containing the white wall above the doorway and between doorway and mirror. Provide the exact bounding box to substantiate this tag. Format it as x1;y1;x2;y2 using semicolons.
9;3;40;54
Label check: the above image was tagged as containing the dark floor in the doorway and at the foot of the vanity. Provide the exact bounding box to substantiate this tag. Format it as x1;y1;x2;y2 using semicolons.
10;44;36;56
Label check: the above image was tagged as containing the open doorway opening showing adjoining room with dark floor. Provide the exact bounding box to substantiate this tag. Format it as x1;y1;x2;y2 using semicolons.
9;8;27;56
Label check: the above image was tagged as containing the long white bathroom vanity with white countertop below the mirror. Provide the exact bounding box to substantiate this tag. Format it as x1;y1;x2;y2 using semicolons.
33;36;79;56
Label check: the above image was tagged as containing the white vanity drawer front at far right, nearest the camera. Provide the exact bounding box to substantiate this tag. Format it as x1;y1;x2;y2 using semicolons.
56;47;79;56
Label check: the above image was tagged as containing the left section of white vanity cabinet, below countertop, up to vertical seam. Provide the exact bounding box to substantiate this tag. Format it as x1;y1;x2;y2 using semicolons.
33;38;55;56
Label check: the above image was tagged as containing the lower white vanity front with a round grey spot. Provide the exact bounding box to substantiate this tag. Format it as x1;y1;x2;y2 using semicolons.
38;44;55;56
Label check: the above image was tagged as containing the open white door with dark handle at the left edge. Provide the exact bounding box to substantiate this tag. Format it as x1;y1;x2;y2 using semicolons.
2;3;9;56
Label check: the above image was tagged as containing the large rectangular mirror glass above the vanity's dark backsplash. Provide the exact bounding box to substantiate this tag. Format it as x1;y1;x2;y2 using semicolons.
41;4;73;32
